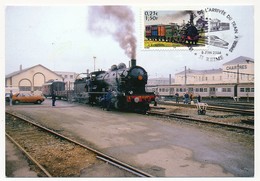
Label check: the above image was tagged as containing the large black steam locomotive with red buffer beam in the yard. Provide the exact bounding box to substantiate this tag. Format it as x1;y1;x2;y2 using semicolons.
43;59;156;112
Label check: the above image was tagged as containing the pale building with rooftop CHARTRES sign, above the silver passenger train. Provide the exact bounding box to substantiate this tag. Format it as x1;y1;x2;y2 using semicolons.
174;56;254;84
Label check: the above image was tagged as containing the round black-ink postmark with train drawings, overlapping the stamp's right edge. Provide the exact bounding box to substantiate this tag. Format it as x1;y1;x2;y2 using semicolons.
189;7;239;62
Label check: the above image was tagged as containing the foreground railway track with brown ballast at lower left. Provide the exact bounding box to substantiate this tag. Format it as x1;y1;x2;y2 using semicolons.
6;112;153;177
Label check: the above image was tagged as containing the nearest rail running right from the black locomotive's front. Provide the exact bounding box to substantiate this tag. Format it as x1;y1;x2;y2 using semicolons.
147;110;254;133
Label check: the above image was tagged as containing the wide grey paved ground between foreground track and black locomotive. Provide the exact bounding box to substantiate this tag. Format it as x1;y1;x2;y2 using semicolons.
6;100;254;177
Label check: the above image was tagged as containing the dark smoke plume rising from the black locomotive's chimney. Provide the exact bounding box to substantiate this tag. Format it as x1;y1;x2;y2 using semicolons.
88;6;136;59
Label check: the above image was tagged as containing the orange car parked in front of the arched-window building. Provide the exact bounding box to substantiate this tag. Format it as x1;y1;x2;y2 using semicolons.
12;93;44;104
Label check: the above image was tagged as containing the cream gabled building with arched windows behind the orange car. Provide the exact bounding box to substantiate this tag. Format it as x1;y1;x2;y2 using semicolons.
5;64;74;92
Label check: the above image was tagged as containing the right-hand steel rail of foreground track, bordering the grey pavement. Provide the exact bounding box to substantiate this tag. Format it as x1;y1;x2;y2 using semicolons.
6;111;154;177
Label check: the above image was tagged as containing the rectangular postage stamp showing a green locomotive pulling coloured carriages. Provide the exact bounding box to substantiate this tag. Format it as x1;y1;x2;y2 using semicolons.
142;9;208;50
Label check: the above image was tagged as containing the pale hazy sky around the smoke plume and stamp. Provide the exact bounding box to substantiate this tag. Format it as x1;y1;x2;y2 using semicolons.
5;5;254;78
